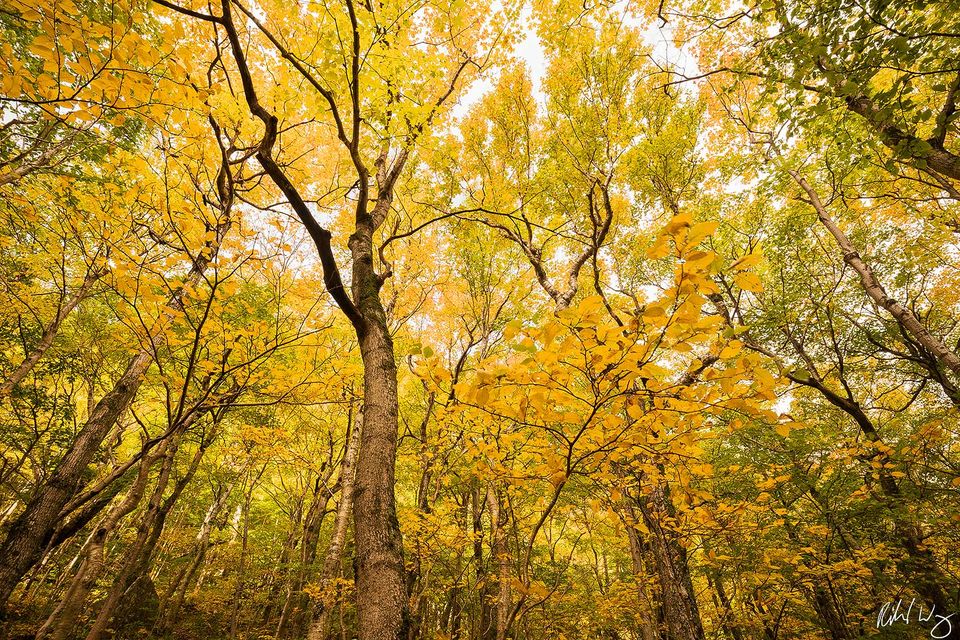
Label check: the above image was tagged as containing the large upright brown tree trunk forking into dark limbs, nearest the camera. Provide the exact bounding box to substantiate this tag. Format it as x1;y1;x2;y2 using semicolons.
208;6;410;640
